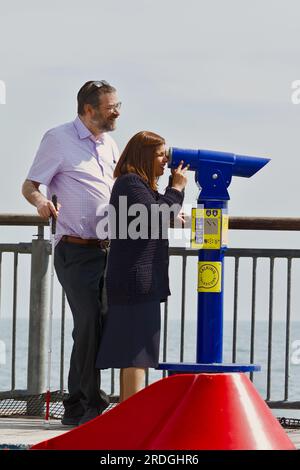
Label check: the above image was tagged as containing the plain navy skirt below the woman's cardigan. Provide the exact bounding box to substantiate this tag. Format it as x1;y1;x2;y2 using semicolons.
96;300;160;369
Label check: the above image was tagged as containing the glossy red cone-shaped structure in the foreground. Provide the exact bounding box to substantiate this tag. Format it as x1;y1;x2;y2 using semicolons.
31;373;295;450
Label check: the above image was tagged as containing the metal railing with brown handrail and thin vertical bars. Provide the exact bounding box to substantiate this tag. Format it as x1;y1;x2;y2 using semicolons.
0;214;300;409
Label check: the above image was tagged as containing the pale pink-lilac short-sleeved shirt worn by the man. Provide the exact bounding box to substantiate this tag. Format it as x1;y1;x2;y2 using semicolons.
27;117;119;241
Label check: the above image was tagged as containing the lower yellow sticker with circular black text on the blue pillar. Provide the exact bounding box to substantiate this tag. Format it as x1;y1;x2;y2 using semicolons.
198;261;222;292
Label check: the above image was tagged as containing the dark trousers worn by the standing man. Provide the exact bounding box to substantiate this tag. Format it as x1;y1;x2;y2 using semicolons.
54;241;109;416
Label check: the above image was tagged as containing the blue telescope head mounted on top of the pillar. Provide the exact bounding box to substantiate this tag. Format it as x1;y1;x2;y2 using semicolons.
168;147;270;200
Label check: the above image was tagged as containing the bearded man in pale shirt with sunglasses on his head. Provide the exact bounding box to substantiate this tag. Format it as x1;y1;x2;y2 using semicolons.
22;80;121;425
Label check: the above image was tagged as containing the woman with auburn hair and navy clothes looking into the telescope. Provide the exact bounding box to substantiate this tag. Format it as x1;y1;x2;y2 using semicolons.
96;131;188;401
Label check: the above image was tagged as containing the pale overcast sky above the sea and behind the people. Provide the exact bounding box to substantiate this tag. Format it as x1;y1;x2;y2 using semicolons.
0;0;300;320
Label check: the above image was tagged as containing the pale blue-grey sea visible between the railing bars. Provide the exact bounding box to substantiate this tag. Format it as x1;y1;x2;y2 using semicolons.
0;316;300;419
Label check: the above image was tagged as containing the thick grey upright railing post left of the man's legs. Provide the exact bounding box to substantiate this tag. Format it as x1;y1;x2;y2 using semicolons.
27;239;49;415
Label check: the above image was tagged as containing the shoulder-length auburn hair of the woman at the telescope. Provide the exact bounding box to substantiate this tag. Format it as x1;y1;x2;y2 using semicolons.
114;131;166;191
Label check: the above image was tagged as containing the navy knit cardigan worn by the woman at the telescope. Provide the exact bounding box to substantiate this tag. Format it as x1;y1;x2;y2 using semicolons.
106;173;184;304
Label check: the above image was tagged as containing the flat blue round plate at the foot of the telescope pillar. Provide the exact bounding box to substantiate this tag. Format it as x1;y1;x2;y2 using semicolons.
156;362;261;375
